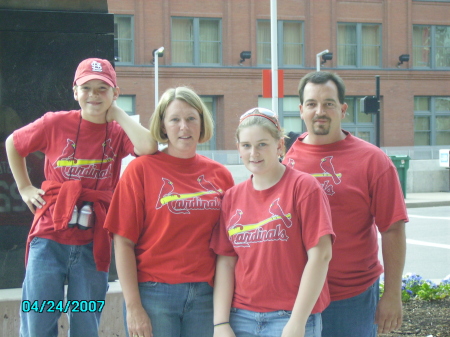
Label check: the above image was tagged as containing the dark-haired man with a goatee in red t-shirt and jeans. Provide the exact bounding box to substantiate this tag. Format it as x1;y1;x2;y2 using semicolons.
284;72;408;337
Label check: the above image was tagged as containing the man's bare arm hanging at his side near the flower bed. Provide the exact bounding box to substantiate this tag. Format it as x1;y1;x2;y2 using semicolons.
375;220;406;333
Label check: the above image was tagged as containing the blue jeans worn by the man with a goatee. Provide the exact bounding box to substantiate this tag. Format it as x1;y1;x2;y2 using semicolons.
322;280;380;337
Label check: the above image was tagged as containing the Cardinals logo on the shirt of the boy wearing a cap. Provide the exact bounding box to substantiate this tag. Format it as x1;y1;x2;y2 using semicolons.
53;138;116;180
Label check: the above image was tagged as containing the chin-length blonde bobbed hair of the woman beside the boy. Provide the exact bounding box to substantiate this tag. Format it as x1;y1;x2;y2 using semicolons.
149;87;214;143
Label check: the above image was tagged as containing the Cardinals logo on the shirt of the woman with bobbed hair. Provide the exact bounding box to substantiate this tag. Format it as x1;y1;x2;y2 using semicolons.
156;174;223;214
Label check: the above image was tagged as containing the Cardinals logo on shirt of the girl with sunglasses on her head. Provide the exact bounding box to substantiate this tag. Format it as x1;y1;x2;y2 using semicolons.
228;198;292;247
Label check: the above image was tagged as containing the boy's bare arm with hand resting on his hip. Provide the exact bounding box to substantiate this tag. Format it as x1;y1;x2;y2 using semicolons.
5;134;45;214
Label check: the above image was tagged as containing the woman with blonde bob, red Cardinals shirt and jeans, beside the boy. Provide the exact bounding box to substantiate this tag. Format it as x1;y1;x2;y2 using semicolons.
105;87;233;337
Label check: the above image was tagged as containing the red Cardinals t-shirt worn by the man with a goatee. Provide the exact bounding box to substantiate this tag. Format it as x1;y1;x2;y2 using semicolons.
283;132;408;301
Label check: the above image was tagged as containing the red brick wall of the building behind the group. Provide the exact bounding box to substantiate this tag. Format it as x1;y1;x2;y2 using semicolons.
108;0;450;149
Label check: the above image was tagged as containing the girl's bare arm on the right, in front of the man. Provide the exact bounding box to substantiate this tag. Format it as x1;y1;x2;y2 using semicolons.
281;235;332;337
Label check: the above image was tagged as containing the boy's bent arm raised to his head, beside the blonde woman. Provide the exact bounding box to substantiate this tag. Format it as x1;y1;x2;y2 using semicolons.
106;101;158;156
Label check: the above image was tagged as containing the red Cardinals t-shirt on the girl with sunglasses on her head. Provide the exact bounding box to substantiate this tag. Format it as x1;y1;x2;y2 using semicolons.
211;167;334;313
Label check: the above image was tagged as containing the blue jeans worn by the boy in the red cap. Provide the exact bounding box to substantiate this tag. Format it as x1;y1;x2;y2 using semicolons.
20;237;108;337
